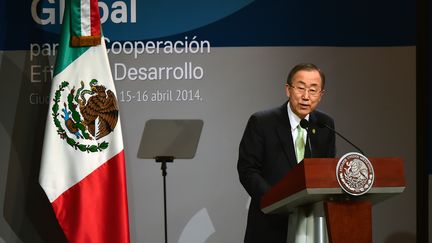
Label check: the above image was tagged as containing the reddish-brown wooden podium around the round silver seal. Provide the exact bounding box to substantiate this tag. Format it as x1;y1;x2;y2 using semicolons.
261;158;405;243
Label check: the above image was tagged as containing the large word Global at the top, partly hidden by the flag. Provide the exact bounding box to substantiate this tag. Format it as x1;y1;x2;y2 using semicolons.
31;0;136;25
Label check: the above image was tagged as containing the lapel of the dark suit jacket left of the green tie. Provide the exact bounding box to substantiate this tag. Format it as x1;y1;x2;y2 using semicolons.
276;103;297;169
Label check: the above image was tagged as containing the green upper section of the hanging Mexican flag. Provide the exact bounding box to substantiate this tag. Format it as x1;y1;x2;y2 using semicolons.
54;0;89;76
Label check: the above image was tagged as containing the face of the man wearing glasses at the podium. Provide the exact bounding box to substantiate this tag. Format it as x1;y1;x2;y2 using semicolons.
285;70;323;119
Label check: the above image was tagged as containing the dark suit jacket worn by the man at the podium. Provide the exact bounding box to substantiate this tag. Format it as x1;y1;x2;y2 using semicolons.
237;103;336;243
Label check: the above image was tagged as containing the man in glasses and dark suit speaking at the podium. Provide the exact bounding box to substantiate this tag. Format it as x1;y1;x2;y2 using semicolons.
237;63;336;243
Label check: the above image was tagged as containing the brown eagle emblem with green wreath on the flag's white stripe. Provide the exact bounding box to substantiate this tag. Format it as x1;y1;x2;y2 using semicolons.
51;79;118;152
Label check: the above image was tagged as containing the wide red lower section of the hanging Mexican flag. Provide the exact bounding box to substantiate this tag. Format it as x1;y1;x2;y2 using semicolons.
52;150;130;243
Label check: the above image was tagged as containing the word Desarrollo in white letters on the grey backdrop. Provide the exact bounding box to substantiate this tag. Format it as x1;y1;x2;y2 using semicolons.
114;62;204;81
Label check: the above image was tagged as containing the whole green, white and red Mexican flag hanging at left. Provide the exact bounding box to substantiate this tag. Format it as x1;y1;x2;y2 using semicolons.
39;0;130;243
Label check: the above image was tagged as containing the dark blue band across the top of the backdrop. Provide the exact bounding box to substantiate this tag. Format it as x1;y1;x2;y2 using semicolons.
0;0;416;50
